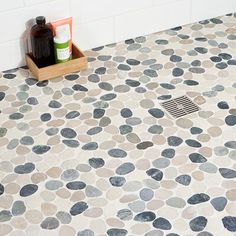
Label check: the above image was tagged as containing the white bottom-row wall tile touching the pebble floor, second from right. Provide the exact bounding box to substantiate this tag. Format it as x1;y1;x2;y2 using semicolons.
115;0;190;42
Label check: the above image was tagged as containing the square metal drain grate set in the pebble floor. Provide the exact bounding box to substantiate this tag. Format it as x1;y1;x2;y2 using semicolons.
161;96;200;118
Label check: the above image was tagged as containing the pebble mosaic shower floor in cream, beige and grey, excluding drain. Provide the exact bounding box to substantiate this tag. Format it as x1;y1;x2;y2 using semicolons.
0;14;236;236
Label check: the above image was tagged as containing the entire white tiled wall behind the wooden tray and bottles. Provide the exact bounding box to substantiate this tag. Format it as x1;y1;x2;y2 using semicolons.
0;0;236;71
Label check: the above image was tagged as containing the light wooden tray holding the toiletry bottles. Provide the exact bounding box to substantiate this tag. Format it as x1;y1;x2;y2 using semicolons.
26;43;88;80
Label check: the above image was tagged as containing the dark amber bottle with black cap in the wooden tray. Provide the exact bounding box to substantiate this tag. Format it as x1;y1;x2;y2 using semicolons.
30;16;55;68
